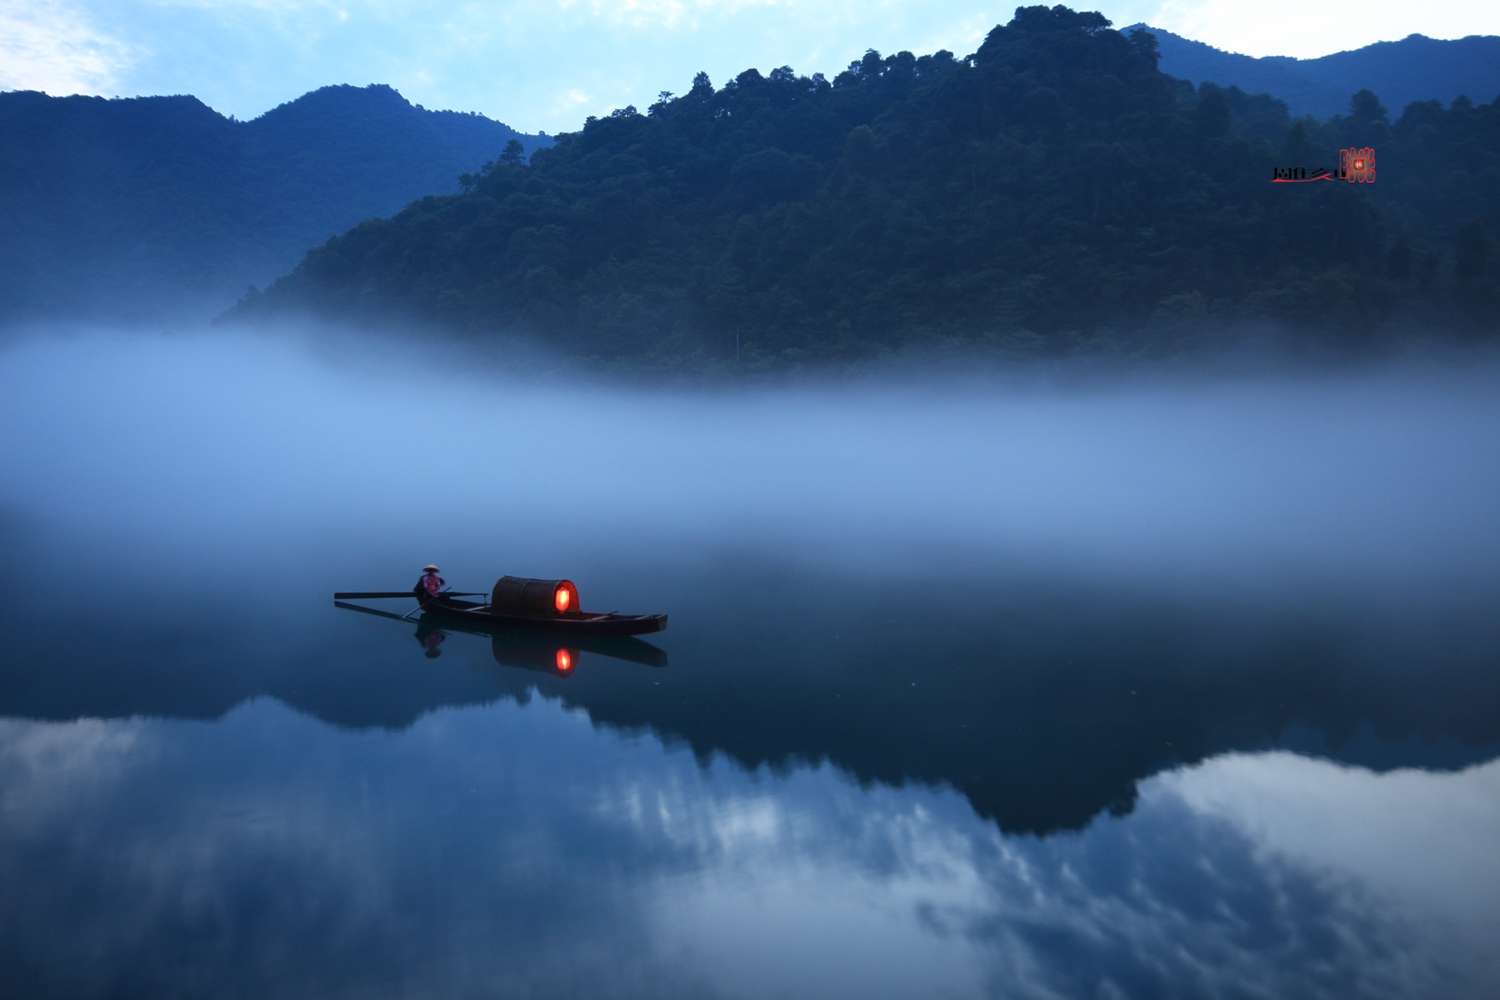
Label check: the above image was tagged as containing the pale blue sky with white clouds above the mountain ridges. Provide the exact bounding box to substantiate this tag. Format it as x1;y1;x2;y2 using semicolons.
0;0;1500;132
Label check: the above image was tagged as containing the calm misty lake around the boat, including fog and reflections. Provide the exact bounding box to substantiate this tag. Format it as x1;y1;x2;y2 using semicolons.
0;333;1500;999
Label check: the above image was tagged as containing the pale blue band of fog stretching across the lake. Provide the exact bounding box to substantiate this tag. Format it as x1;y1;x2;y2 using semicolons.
0;331;1500;602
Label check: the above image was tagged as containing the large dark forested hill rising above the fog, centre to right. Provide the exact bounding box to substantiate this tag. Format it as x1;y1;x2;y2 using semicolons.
233;6;1500;369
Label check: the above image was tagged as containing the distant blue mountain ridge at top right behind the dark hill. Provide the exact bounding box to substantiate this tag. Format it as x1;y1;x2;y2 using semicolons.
1146;25;1500;118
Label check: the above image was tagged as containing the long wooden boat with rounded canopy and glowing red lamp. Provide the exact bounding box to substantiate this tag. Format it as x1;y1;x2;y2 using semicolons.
343;576;666;636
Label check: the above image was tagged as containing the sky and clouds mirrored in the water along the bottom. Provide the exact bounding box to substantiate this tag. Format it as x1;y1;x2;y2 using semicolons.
0;699;1500;997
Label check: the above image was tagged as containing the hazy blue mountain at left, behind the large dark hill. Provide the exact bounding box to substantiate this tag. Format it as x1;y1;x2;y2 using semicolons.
0;85;549;321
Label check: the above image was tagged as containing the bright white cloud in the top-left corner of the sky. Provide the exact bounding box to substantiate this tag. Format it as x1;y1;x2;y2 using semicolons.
0;0;140;94
